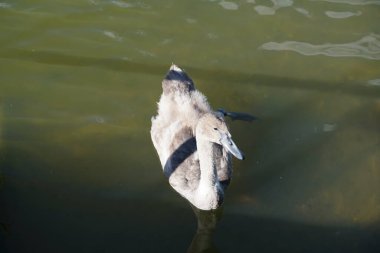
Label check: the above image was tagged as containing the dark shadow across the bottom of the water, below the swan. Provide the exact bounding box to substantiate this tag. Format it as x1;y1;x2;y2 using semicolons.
0;188;380;253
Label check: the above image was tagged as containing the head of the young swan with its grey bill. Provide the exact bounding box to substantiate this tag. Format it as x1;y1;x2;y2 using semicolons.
196;113;244;160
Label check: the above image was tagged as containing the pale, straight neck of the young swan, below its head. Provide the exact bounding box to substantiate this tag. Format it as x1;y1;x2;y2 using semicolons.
196;139;223;210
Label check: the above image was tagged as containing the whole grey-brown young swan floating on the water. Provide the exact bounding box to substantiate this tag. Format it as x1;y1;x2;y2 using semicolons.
151;65;243;210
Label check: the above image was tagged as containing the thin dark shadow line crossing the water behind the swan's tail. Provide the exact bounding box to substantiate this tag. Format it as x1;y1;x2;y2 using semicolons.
0;49;380;98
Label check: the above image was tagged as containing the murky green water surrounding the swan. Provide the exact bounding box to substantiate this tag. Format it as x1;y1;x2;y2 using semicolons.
0;0;380;252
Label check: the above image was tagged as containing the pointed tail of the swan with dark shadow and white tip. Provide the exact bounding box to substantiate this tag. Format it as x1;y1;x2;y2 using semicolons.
162;64;195;95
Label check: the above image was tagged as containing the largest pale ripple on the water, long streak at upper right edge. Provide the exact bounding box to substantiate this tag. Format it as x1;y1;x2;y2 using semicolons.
260;34;380;60
